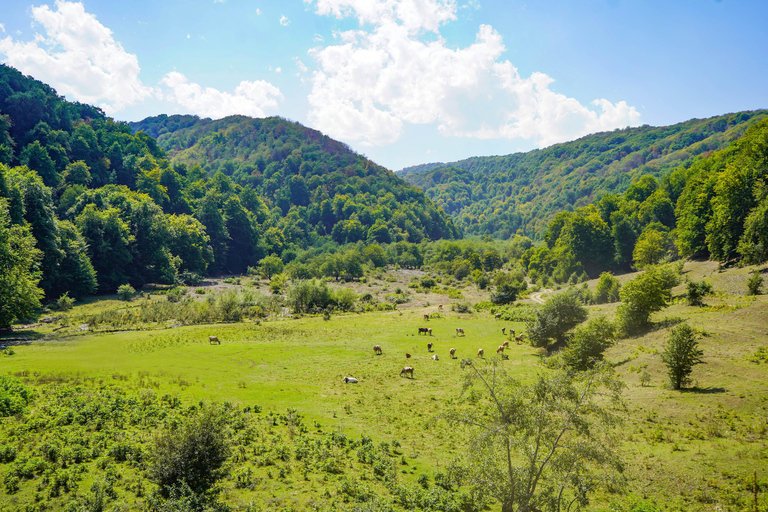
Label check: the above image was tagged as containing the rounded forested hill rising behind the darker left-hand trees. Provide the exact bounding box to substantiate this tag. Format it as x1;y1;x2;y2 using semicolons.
130;115;459;243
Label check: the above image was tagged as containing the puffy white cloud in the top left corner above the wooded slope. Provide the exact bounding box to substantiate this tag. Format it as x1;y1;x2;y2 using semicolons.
0;0;155;113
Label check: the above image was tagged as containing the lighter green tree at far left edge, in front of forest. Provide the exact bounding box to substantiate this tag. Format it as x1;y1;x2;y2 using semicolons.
0;198;43;329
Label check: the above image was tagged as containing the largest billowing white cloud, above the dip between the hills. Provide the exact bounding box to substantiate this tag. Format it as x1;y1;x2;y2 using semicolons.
305;0;640;147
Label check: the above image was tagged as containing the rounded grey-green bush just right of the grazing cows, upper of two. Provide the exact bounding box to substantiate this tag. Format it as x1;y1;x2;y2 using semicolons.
527;290;587;347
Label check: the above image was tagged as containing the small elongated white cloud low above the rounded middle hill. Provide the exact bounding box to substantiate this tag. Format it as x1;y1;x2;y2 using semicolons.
160;71;283;119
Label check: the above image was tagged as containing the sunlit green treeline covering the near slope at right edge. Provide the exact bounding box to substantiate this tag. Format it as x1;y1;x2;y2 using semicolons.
520;120;768;282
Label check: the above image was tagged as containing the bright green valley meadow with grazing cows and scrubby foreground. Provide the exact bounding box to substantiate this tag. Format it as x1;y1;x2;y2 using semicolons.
0;263;768;511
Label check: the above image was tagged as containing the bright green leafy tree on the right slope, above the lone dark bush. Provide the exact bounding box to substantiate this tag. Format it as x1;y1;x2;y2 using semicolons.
617;264;680;336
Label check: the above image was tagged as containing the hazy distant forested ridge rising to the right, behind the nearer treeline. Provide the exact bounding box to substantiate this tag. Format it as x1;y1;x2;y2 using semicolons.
398;110;768;238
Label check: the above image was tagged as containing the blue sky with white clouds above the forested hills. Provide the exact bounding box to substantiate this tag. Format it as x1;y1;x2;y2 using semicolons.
0;0;768;170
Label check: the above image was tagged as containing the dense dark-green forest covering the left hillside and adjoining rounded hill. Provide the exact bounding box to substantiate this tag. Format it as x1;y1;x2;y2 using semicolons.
0;65;459;325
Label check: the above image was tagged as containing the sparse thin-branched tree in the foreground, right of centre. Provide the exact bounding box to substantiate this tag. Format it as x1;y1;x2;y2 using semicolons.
449;365;623;512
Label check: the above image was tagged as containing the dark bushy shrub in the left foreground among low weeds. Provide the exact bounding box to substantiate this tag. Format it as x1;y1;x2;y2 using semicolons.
149;407;230;498
